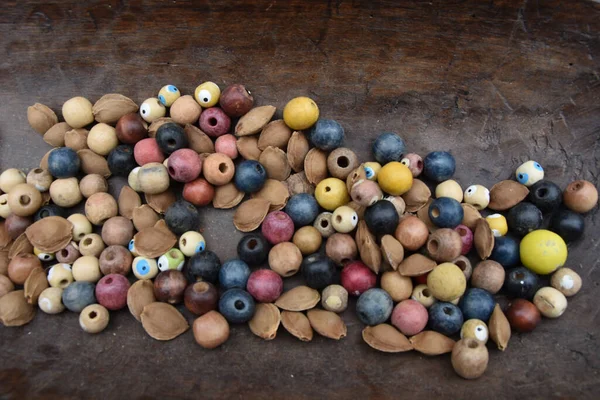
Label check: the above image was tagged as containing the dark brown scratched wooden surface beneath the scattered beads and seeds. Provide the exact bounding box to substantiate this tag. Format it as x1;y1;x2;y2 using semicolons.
0;0;600;399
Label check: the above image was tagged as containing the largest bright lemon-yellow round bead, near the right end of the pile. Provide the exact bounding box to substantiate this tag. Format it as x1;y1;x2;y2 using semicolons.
520;229;567;275
